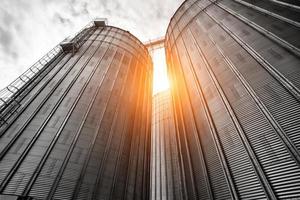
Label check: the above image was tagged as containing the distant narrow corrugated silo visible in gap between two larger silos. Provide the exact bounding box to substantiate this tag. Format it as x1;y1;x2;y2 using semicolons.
150;90;183;200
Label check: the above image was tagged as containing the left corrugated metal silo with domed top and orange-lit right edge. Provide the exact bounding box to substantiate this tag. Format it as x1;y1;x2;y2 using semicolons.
0;22;152;199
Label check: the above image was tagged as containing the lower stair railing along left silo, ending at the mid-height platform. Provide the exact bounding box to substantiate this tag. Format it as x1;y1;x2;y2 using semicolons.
0;45;62;109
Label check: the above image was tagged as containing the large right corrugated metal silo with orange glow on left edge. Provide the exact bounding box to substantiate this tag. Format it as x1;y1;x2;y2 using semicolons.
165;0;300;199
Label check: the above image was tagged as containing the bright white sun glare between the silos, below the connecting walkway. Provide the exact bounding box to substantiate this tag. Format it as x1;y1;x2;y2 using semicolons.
151;48;170;95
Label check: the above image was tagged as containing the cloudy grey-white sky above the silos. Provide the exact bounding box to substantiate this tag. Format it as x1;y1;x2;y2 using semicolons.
0;0;183;89
